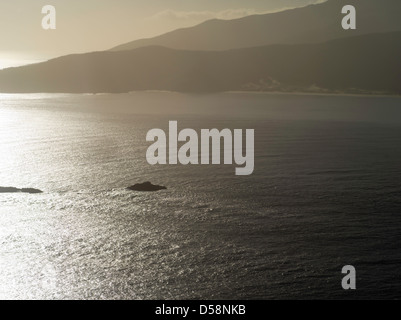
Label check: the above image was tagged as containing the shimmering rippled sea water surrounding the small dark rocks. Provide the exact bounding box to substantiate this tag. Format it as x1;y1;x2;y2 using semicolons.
0;92;401;299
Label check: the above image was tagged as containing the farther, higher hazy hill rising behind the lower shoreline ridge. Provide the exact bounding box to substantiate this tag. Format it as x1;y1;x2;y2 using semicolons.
111;0;401;51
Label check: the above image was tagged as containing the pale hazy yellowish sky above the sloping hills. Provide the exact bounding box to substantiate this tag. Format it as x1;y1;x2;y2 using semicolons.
0;0;321;69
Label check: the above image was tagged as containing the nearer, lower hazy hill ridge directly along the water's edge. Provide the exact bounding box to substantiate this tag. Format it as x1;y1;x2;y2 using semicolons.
0;32;401;94
